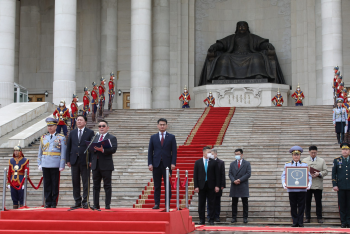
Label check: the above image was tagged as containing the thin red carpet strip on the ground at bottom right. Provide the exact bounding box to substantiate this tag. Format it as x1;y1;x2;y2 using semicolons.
196;226;350;233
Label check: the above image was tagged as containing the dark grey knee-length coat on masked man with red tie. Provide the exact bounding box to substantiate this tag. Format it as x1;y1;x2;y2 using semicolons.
228;159;251;197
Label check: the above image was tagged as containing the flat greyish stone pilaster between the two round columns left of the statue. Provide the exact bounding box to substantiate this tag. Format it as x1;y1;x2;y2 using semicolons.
101;0;118;78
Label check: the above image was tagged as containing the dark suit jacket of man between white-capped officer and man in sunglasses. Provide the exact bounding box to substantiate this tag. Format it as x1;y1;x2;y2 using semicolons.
66;127;94;165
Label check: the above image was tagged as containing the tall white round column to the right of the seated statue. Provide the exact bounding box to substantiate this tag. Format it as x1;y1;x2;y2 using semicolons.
321;0;343;105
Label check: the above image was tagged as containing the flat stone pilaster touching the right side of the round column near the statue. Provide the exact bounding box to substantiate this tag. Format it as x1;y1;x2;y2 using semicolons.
152;0;170;108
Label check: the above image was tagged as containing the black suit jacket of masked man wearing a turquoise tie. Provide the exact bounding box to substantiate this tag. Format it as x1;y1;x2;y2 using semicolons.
193;158;220;189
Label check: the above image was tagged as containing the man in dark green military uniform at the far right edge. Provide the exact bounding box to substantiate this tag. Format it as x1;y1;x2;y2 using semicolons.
332;142;350;228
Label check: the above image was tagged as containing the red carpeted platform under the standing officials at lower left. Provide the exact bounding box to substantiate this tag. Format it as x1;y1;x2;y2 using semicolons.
0;208;194;234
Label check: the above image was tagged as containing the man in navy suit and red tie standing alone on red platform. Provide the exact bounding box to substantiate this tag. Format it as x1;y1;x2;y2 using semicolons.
148;118;177;209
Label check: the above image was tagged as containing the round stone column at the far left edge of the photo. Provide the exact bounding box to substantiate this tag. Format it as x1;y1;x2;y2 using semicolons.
0;0;16;107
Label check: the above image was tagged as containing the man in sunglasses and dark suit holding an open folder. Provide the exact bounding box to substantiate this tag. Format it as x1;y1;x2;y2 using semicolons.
91;120;118;209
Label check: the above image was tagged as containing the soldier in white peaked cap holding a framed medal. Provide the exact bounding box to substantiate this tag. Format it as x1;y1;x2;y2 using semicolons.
281;146;312;227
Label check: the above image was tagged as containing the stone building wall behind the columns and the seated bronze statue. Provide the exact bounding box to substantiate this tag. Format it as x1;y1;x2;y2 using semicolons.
0;0;350;108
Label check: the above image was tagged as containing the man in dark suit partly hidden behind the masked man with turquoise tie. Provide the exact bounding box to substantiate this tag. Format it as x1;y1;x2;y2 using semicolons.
207;148;226;222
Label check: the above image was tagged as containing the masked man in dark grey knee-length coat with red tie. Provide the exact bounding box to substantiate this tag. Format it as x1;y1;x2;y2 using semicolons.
229;149;251;223
